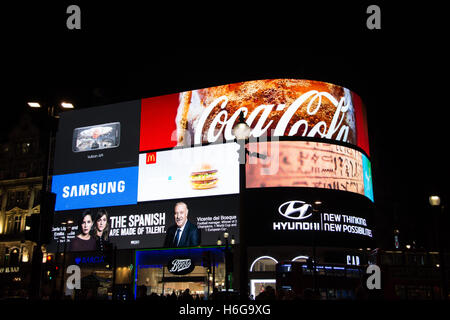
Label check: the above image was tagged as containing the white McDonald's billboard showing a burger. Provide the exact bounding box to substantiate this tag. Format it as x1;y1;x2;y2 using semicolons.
138;143;239;202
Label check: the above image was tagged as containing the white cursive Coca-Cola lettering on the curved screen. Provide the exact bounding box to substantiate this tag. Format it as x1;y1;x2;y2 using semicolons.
194;89;353;144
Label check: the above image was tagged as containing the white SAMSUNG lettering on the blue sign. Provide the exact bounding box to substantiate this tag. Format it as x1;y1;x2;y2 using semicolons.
62;180;125;198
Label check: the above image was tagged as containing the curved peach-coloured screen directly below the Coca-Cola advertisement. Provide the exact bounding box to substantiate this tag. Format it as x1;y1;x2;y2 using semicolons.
246;141;373;201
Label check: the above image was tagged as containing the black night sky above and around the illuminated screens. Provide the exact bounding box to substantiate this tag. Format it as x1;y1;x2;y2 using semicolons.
1;3;449;250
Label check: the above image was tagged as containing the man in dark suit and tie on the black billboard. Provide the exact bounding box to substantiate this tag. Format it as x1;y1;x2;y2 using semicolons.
164;202;200;248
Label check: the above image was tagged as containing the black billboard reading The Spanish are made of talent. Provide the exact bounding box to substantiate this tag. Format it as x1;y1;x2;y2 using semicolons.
49;195;239;251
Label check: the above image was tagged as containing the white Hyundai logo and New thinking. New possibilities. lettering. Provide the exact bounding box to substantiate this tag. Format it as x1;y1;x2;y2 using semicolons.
273;200;372;238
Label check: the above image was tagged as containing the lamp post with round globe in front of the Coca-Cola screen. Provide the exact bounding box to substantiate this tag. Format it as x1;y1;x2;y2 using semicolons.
233;112;250;300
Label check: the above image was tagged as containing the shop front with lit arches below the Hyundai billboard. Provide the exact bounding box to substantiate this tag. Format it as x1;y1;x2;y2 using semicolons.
249;246;370;300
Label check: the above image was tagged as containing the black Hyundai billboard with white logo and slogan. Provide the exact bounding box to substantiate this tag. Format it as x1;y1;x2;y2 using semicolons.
246;187;374;248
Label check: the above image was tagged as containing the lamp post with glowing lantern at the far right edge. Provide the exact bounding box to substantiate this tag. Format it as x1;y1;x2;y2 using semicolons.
428;195;448;300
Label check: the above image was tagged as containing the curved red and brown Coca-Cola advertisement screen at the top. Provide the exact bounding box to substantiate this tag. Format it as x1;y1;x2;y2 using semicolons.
140;79;369;155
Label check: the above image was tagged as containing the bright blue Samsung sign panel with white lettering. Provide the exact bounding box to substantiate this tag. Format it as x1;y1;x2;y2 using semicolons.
52;166;139;211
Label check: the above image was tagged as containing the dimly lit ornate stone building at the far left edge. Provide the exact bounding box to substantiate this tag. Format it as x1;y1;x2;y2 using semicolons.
0;113;45;297
